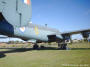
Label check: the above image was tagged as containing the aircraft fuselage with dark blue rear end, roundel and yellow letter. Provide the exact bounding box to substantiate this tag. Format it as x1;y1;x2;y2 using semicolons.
0;20;62;42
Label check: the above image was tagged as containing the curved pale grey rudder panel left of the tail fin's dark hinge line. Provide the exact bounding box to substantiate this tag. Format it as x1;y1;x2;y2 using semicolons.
2;0;20;26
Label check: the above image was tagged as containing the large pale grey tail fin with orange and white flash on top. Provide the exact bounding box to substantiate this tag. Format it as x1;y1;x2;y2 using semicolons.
2;0;32;27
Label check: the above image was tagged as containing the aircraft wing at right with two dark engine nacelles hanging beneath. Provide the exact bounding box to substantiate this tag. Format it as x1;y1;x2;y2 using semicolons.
61;29;90;39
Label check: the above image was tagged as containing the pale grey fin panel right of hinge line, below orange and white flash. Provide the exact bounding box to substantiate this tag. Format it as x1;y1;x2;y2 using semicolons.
18;0;32;26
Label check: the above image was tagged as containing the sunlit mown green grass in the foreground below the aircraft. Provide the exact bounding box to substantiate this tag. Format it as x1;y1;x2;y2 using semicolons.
0;43;90;67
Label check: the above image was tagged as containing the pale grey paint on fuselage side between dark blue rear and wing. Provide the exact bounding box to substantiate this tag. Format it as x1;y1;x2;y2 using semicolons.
14;24;62;41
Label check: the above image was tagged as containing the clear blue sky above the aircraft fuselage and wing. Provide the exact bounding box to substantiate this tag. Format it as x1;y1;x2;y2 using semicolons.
0;0;90;42
